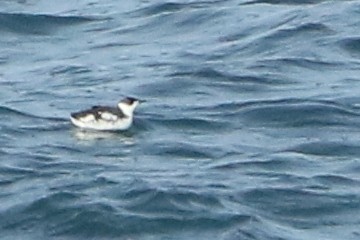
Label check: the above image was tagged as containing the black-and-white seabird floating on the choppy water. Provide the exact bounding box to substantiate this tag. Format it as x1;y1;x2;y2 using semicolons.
70;97;143;130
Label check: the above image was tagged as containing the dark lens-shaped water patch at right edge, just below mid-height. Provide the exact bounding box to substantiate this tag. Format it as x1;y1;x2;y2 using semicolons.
285;141;360;157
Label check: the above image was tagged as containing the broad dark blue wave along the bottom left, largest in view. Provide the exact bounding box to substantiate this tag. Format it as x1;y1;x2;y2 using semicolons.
1;182;254;238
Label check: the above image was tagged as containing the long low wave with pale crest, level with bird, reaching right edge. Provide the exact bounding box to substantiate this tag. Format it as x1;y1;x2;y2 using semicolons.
194;99;360;127
